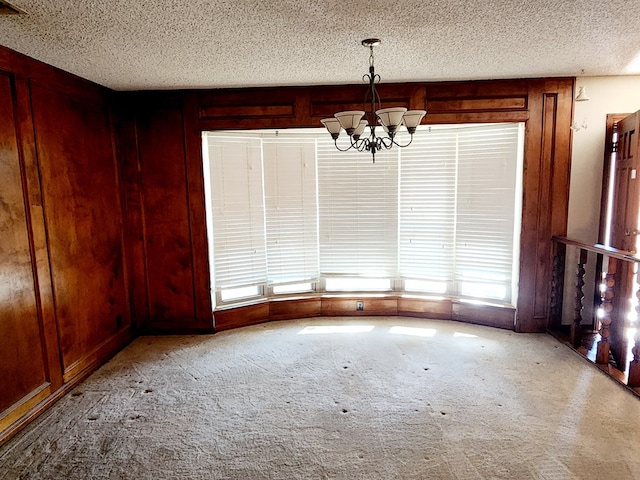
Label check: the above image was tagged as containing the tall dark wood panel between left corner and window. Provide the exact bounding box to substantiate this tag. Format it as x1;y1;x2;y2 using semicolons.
137;106;195;328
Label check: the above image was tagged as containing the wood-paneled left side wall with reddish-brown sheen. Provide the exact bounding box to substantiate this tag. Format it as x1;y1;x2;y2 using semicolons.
0;48;132;443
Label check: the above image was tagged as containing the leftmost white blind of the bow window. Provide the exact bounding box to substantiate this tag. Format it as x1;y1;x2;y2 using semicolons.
208;135;267;291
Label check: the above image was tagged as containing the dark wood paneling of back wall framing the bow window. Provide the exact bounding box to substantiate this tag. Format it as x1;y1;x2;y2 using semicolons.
124;78;574;332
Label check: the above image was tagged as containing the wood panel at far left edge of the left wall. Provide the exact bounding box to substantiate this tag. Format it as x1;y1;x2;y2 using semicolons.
0;74;48;417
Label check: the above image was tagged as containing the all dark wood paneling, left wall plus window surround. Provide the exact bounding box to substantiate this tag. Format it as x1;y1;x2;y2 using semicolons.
0;39;574;443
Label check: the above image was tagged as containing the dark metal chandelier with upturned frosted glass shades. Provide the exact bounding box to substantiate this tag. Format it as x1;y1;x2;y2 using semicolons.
320;38;427;163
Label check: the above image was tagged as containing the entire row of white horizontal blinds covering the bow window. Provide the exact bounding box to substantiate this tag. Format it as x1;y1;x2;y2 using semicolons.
205;123;524;302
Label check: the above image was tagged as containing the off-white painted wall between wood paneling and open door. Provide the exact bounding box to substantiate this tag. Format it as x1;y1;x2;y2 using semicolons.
567;76;640;243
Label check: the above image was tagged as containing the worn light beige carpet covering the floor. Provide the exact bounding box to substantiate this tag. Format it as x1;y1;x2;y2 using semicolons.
0;317;640;480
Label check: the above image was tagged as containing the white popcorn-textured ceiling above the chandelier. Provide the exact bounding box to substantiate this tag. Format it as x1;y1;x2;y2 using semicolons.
0;0;640;90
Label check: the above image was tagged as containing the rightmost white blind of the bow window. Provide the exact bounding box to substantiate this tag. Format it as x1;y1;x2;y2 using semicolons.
456;123;519;300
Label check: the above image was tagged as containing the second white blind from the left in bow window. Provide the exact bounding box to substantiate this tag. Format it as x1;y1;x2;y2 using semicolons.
263;139;318;284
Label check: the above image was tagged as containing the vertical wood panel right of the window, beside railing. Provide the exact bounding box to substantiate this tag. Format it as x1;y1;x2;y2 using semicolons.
516;80;573;332
